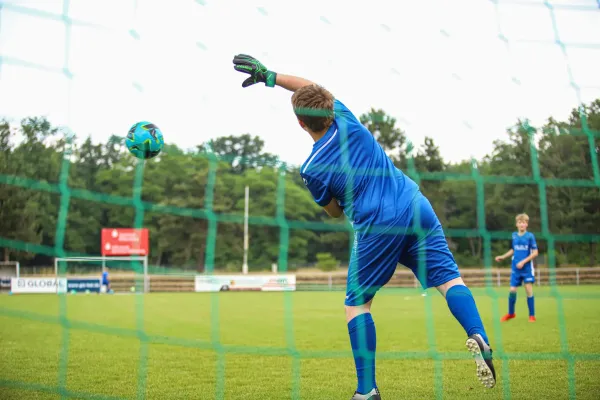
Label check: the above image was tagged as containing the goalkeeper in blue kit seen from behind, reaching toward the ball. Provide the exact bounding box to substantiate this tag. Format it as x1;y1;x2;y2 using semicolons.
233;54;496;400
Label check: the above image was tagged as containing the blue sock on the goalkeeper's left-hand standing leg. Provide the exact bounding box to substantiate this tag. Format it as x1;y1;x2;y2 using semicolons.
348;313;377;394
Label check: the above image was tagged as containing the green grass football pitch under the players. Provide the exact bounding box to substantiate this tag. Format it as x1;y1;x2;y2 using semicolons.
0;286;600;400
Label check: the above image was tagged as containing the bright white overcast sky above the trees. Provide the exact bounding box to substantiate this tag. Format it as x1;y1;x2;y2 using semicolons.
0;0;600;164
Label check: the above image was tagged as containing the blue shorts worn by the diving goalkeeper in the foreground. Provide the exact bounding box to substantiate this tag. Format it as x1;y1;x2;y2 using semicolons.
345;192;460;306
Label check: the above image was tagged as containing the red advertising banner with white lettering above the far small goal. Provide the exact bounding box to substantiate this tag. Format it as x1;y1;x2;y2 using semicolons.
101;228;149;256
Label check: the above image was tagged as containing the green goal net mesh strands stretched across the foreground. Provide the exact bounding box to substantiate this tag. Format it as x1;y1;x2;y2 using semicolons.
0;0;600;399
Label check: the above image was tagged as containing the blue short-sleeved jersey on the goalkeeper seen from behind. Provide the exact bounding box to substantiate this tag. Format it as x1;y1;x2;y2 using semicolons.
300;100;419;230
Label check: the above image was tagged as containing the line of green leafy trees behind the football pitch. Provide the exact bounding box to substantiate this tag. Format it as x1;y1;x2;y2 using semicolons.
0;99;600;270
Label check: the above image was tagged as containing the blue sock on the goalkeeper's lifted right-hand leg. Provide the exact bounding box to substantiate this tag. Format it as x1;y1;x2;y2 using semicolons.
446;285;490;344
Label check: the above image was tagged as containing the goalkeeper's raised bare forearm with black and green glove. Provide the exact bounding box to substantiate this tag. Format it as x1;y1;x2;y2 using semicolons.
233;54;314;92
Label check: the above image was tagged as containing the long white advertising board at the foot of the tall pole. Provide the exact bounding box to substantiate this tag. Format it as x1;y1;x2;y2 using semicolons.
195;274;296;292
